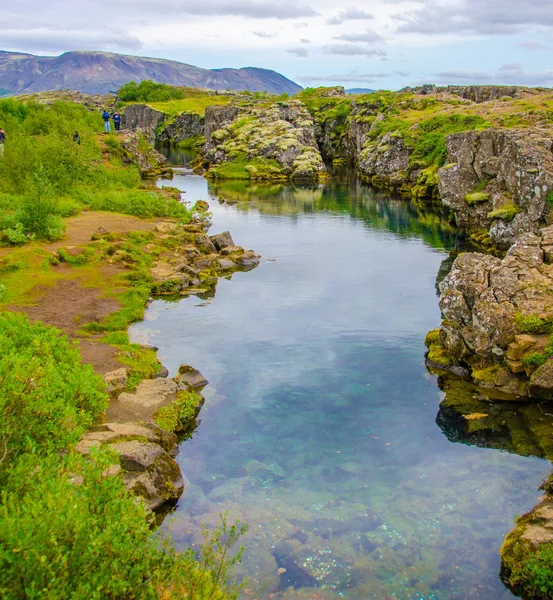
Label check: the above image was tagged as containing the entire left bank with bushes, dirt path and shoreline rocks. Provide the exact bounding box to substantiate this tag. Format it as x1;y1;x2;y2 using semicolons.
0;100;258;600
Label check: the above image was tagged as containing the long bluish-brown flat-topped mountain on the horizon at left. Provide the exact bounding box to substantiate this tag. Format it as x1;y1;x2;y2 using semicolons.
0;51;302;95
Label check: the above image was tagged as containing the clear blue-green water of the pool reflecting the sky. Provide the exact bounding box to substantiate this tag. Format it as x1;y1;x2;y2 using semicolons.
132;168;549;600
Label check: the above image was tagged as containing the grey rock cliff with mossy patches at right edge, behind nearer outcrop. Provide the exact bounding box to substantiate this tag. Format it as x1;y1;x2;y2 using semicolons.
438;129;553;250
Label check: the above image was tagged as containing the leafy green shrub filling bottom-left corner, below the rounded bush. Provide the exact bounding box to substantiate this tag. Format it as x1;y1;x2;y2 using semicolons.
0;453;245;600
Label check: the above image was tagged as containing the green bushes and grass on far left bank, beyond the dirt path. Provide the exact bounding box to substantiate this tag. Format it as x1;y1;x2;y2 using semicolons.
0;99;188;245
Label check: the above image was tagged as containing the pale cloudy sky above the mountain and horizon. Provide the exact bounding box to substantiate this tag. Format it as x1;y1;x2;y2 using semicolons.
0;0;553;89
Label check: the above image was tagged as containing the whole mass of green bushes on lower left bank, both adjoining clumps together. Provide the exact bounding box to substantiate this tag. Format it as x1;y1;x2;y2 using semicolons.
0;313;245;600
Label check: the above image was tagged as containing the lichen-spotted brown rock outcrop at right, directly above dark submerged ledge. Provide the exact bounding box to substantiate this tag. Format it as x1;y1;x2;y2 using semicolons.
429;227;553;399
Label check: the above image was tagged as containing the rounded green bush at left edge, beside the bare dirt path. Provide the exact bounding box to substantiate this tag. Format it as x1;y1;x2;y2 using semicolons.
0;313;107;483
